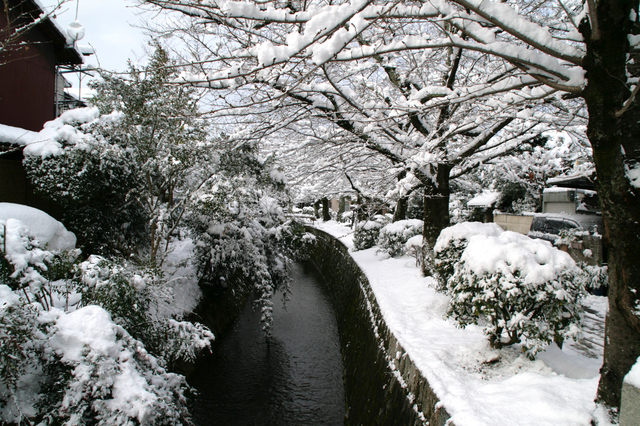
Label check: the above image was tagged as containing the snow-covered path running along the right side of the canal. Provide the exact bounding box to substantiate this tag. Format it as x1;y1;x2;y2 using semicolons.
316;222;607;426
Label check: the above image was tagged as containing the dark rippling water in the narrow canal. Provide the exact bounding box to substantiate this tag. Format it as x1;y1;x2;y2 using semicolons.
189;265;344;426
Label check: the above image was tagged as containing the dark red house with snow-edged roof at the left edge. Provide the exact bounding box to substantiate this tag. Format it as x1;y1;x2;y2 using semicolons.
0;0;83;218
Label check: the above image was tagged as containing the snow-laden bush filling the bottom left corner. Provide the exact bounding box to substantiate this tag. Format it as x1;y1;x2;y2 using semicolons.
0;284;194;425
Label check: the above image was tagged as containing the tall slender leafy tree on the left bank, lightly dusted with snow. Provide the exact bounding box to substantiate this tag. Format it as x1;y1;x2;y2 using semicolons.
91;44;213;263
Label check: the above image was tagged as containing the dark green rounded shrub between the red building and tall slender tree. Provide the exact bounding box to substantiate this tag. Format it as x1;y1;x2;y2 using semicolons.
24;148;148;256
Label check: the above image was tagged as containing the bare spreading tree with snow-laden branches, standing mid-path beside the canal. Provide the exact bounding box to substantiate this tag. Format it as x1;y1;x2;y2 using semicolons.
140;1;581;280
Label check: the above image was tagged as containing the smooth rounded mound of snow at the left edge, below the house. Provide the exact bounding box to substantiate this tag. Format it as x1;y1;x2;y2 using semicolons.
0;203;76;250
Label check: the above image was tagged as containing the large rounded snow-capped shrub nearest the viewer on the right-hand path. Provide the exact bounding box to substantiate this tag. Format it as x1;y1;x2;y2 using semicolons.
442;231;586;356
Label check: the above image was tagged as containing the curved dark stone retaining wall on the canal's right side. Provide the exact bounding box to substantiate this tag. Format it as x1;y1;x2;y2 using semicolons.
307;227;449;426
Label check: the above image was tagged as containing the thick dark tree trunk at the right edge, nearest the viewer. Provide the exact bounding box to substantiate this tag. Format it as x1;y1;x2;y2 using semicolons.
580;0;640;407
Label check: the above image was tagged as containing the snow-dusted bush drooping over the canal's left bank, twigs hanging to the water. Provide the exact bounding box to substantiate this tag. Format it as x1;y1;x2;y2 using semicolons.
187;140;313;333
